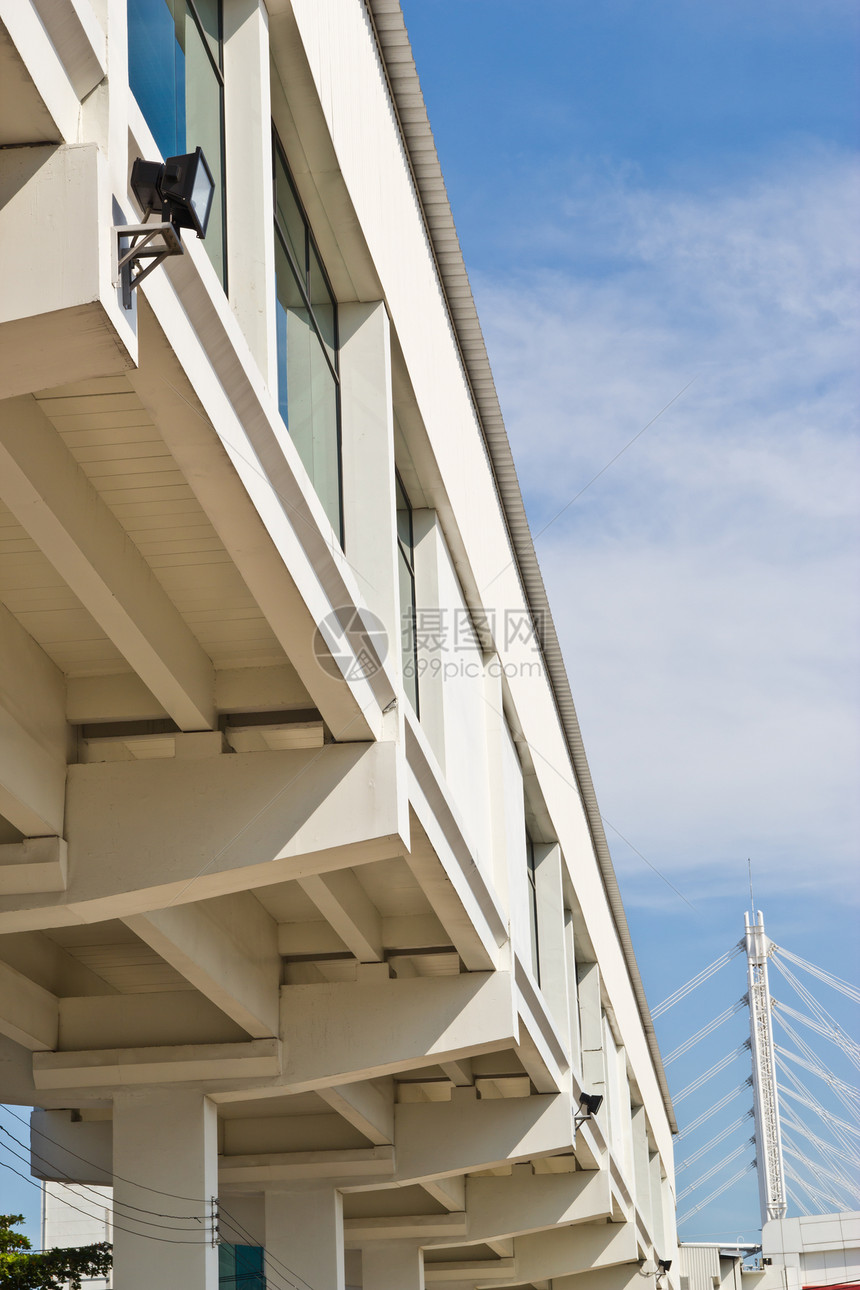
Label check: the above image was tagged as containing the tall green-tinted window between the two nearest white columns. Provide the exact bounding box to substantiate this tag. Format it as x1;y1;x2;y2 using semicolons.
273;139;343;543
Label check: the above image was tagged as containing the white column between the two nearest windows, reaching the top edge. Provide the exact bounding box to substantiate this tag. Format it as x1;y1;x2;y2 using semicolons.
224;0;277;387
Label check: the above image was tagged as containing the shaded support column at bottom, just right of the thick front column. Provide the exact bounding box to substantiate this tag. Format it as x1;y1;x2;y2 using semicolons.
266;1187;344;1290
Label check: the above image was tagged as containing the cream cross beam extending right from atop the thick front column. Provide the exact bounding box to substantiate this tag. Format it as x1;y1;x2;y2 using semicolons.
281;973;514;1093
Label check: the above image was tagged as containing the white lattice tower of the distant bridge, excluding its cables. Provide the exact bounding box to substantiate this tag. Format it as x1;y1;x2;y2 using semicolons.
744;909;788;1224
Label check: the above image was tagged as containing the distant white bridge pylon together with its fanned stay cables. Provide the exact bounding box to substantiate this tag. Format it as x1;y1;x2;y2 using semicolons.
652;911;860;1226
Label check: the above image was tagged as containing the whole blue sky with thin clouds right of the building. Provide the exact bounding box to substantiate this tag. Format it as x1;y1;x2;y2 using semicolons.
404;0;860;1240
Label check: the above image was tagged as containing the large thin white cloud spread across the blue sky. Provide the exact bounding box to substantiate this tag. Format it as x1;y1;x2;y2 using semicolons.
477;147;860;898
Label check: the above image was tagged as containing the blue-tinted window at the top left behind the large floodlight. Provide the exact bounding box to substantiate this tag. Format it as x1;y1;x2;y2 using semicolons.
128;0;227;284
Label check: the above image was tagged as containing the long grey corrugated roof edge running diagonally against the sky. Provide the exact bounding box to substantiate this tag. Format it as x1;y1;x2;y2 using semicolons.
365;0;678;1133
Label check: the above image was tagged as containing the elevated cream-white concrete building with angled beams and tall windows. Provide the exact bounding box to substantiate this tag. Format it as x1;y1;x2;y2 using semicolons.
0;0;678;1290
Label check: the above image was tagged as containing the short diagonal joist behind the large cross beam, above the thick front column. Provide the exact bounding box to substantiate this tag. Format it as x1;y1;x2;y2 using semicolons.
124;891;281;1038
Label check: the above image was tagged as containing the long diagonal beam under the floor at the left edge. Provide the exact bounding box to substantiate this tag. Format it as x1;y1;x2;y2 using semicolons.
0;397;215;730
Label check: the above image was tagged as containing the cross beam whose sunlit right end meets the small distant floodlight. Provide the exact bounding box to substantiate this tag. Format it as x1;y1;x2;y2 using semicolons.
395;1089;572;1182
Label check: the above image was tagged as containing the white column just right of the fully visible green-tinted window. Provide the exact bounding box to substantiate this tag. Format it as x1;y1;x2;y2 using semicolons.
338;296;401;655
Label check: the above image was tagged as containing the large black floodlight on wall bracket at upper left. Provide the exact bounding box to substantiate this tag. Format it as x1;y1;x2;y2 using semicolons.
113;148;215;310
